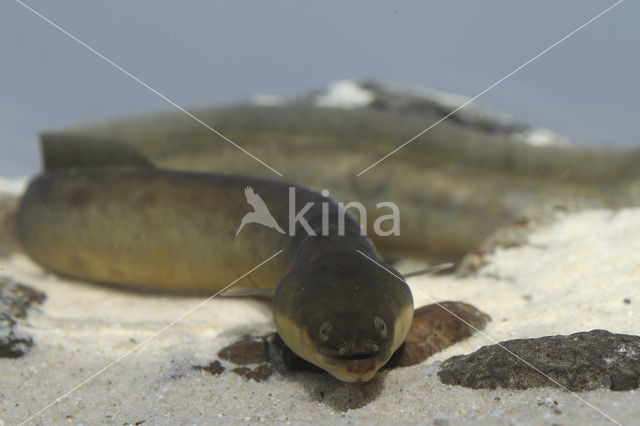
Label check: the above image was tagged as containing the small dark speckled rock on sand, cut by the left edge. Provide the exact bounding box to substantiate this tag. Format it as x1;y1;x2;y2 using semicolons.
0;277;46;358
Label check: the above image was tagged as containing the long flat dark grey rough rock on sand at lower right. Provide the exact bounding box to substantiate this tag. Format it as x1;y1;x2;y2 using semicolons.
438;330;640;391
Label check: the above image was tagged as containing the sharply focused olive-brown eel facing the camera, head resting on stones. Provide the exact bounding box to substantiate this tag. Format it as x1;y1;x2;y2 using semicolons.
17;141;413;382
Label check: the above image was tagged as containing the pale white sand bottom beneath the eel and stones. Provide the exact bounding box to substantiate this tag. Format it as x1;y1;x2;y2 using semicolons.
0;210;640;425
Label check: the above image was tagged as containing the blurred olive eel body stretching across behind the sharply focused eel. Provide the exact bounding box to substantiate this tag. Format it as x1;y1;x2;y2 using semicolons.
47;104;640;262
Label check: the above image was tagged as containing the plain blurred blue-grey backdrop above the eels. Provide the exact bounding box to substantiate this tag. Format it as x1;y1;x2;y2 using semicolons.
0;0;640;176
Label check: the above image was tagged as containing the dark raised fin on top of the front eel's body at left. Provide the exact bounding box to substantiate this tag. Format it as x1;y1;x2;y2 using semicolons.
40;133;154;171
